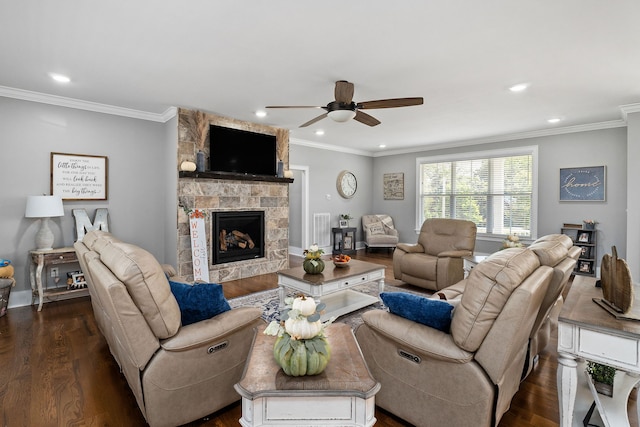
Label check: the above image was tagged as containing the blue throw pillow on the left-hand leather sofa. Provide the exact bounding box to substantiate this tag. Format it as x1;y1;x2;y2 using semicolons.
169;280;231;326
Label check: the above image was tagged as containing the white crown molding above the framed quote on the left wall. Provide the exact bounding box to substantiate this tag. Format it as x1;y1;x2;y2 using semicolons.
0;86;177;123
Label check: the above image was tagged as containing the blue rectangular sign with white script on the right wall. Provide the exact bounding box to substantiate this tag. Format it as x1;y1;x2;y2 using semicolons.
560;166;606;202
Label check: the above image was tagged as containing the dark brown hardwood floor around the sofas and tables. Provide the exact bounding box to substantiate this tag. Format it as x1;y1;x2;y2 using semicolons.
0;250;637;427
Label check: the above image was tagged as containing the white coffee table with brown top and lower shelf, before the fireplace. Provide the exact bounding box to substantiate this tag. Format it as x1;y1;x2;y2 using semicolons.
277;259;385;321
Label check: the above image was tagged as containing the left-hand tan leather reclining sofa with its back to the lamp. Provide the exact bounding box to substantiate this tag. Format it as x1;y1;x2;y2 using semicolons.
74;230;264;427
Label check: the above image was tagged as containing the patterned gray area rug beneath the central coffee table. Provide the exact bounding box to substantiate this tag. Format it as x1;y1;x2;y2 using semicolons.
229;282;428;329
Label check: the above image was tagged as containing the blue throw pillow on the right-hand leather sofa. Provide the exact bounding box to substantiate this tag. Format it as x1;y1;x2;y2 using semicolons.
380;292;453;332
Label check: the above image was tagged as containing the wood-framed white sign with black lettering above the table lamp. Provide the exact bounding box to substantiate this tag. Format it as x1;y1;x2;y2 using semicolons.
51;153;107;200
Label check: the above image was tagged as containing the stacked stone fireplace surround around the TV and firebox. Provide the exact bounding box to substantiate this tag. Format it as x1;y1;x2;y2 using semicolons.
177;109;289;283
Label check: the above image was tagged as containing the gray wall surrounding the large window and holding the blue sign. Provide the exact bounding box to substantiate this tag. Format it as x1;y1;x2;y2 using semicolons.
372;128;627;264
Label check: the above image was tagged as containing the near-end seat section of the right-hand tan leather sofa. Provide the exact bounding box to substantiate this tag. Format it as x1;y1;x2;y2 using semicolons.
356;248;553;427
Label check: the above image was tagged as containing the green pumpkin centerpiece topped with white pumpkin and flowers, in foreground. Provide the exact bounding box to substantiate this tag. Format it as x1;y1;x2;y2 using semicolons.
264;295;335;377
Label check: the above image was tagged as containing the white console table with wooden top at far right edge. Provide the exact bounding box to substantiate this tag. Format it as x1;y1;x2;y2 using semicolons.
557;276;640;427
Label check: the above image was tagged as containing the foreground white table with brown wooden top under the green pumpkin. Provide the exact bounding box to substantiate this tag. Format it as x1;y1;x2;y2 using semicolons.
235;323;380;427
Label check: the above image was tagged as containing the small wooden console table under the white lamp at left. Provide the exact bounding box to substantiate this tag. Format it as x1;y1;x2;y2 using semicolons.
29;248;89;311
